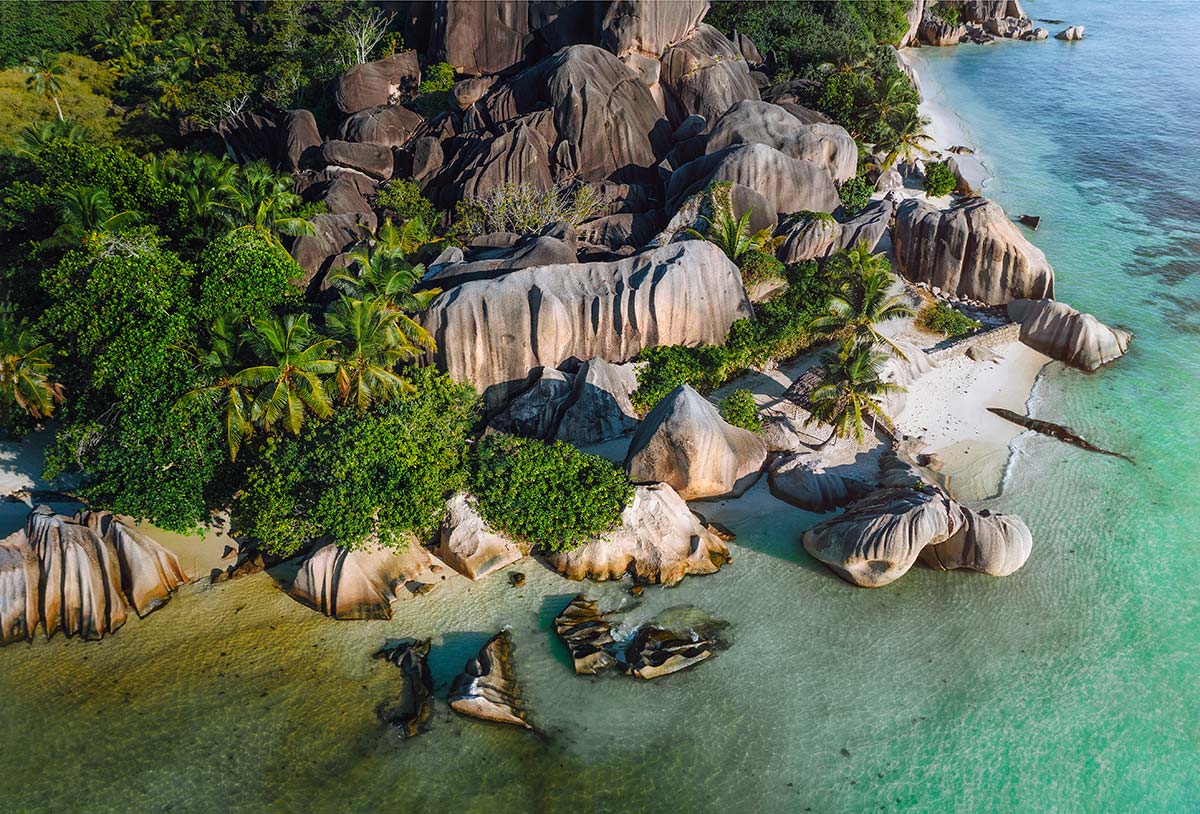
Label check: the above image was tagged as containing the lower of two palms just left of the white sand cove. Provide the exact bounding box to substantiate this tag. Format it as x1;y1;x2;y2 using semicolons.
804;340;901;447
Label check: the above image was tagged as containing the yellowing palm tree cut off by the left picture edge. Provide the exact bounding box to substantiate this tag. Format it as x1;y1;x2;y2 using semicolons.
0;307;64;425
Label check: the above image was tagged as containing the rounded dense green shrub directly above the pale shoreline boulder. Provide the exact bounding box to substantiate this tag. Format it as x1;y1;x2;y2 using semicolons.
472;435;634;551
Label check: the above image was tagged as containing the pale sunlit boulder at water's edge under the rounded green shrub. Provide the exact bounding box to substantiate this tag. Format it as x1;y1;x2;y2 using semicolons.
546;484;730;585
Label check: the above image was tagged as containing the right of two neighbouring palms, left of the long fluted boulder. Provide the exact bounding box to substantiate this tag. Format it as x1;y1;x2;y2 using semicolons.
325;297;424;413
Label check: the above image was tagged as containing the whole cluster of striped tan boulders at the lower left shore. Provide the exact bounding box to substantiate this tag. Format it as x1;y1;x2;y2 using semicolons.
0;505;187;645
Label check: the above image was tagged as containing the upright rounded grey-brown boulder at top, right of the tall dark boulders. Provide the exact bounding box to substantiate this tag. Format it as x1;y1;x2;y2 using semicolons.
660;23;758;127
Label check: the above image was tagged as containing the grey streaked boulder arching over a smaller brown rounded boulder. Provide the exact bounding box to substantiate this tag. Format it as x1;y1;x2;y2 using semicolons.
667;144;841;215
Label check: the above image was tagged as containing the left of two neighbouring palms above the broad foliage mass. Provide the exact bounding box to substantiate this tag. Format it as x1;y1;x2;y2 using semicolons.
235;315;337;435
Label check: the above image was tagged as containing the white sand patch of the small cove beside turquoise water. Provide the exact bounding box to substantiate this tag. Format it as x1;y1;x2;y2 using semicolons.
895;342;1050;501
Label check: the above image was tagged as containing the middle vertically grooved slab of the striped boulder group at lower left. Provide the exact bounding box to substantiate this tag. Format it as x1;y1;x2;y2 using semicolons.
25;507;127;639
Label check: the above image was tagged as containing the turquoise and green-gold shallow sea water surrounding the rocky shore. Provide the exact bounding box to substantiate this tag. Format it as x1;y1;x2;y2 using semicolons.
0;0;1200;814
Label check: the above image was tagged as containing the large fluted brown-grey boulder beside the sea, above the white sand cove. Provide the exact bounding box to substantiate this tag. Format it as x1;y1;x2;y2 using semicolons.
894;198;1054;305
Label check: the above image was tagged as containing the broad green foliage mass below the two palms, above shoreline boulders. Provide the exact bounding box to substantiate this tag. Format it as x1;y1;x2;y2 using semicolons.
233;369;478;555
